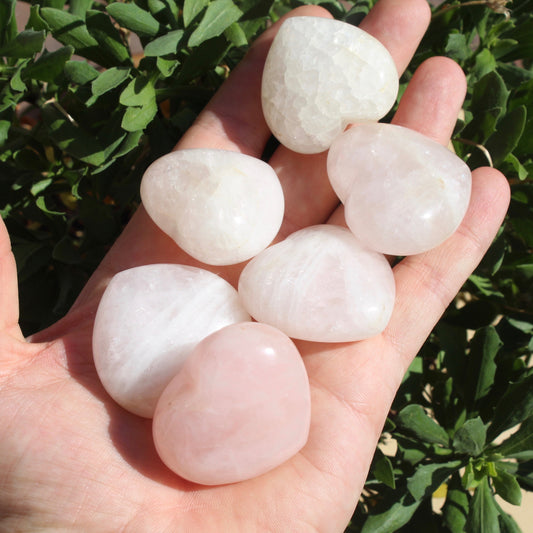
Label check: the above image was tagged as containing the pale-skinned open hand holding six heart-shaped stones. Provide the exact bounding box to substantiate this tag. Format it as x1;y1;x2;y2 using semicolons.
0;0;509;533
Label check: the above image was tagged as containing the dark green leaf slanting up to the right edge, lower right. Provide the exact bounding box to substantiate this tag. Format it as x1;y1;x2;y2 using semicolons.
487;374;533;442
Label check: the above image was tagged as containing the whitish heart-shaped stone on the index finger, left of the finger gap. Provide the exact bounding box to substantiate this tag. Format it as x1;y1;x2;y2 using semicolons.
141;149;284;265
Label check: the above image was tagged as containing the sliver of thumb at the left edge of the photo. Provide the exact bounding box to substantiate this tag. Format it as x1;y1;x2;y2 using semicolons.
0;220;23;339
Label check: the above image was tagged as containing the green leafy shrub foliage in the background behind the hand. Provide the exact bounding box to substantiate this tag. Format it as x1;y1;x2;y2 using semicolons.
0;0;533;533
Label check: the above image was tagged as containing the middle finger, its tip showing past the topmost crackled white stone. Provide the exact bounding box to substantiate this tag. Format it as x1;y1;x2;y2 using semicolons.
269;0;430;235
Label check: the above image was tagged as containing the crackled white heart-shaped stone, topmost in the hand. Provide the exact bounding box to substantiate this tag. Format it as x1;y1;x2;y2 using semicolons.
262;17;398;153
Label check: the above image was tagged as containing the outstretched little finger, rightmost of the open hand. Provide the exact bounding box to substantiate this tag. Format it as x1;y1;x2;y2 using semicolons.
385;168;510;370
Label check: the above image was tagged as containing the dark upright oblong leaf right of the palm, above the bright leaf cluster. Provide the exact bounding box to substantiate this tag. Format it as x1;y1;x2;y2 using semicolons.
467;326;503;408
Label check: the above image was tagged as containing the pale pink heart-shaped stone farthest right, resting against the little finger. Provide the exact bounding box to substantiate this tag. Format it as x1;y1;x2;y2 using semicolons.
328;124;472;255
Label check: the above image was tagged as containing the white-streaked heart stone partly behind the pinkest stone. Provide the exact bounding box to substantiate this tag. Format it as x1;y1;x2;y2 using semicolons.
93;264;250;417
